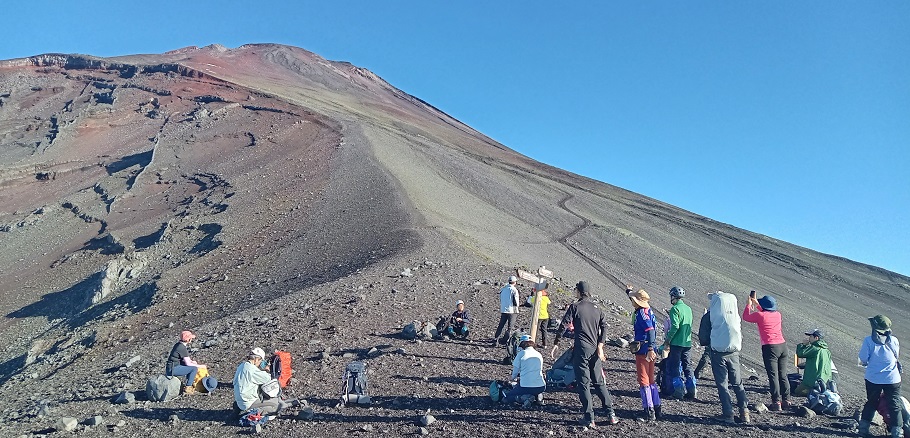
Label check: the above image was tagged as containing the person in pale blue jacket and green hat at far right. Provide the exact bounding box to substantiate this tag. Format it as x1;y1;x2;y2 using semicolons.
859;315;904;438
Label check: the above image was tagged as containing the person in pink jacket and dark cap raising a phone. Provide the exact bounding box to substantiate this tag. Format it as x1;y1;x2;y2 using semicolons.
743;291;796;411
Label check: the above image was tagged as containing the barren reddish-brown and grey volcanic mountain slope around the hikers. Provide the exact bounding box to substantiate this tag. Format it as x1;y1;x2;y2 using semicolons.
0;45;910;436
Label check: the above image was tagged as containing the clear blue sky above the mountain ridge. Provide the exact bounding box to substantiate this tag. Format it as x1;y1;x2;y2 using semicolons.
0;0;910;275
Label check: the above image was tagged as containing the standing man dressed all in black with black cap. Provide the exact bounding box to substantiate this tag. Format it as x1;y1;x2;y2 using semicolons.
550;281;619;428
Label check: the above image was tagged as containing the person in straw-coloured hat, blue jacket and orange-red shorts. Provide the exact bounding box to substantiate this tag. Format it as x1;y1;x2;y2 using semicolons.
626;288;661;421
